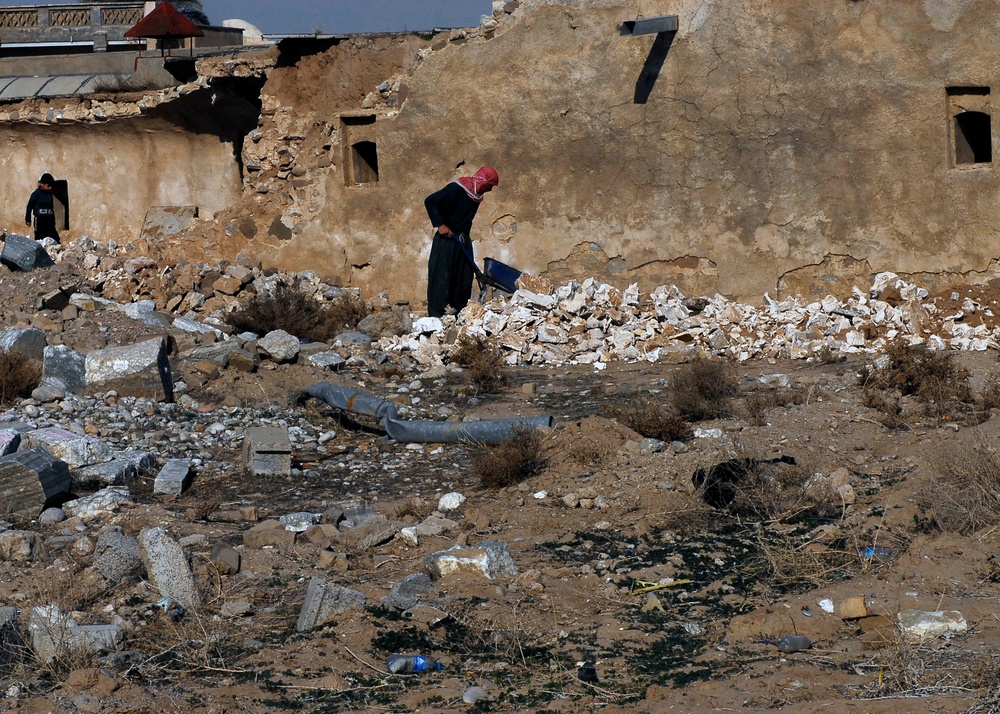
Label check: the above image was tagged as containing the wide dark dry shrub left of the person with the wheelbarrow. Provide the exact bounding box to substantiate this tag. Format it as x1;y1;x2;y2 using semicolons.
229;285;368;342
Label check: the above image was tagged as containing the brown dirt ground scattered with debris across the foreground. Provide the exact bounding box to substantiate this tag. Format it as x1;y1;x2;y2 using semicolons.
0;253;1000;714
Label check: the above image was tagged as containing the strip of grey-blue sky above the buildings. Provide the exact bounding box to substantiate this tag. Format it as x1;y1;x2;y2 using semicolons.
0;0;493;35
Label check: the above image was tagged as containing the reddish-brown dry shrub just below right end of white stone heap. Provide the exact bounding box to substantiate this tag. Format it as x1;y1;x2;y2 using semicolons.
861;342;972;413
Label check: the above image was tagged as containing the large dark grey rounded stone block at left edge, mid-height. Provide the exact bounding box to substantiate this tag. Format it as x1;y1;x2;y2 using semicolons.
0;448;72;517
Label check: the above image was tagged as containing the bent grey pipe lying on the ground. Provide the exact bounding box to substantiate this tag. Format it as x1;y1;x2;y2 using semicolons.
305;382;556;444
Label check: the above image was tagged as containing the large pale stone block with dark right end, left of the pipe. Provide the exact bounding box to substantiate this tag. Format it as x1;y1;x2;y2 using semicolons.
86;338;174;402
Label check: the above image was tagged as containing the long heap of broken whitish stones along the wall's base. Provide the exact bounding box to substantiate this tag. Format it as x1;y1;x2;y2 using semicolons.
380;272;1000;369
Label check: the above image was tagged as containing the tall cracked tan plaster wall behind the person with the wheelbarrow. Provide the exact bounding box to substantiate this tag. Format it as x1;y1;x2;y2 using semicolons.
236;0;1000;301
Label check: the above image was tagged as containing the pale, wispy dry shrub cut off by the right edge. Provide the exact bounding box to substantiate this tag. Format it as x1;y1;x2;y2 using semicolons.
918;439;1000;535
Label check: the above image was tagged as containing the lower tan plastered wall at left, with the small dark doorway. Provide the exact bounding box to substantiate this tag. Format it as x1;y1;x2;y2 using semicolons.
0;68;259;244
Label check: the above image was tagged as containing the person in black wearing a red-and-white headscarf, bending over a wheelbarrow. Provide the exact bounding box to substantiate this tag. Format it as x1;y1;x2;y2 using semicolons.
424;166;500;317
